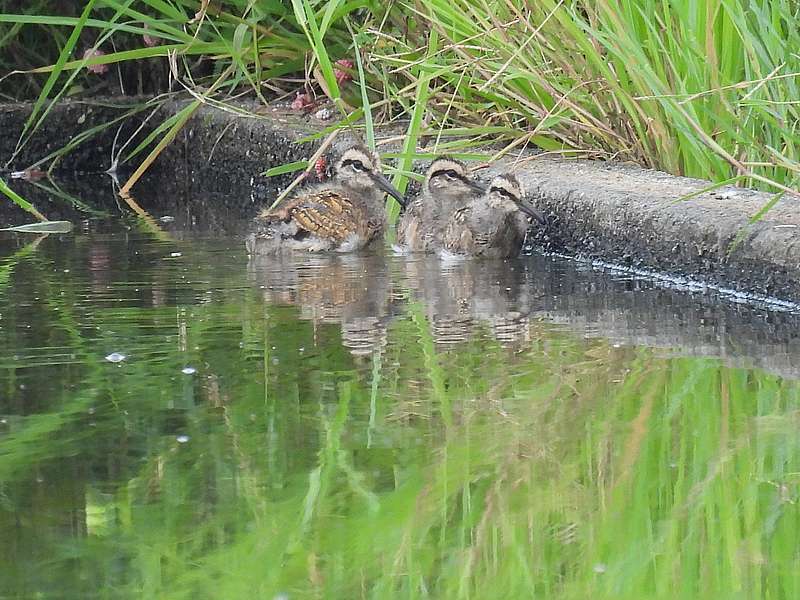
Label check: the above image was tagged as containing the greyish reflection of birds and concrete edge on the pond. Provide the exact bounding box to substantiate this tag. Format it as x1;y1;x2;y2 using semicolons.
248;254;800;378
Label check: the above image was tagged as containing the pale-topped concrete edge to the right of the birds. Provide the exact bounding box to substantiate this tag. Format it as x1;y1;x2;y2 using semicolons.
496;158;800;301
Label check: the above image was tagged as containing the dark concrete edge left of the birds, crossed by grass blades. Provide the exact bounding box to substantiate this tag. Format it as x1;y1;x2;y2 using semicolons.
0;101;317;203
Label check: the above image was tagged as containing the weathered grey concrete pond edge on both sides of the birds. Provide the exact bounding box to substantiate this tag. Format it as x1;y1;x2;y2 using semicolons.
0;103;800;301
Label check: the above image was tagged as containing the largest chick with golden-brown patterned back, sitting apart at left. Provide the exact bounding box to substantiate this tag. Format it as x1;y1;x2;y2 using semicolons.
245;144;405;254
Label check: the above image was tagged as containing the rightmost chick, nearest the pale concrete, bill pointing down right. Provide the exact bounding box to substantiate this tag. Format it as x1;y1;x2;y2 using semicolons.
440;173;545;258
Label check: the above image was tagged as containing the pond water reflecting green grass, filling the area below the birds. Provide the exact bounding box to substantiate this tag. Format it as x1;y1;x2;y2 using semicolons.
0;225;800;599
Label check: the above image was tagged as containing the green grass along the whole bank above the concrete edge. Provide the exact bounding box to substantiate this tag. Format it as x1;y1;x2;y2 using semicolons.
0;0;800;216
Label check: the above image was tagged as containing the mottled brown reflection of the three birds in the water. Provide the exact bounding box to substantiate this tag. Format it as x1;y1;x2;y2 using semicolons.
249;253;535;357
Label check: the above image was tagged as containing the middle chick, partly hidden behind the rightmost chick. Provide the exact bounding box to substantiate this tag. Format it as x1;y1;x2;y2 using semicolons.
395;156;485;253
